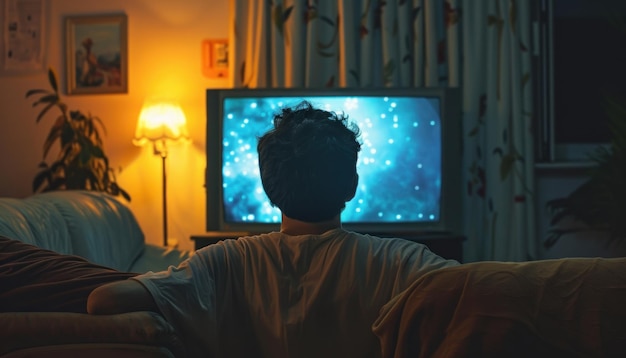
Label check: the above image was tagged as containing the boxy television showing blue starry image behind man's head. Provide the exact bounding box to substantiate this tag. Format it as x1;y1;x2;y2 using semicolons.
205;88;462;236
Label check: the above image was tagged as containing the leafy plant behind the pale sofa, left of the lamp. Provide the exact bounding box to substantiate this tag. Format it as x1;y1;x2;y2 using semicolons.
26;68;130;201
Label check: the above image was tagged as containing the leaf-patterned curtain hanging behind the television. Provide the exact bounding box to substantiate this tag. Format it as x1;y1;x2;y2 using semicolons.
230;0;538;262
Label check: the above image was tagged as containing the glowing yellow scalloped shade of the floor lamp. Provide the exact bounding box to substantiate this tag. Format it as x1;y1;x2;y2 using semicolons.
133;100;189;145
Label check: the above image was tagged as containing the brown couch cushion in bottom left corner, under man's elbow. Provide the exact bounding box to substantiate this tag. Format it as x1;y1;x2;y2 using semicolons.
0;312;187;357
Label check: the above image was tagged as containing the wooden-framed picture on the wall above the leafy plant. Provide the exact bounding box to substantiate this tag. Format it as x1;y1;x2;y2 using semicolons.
65;14;128;95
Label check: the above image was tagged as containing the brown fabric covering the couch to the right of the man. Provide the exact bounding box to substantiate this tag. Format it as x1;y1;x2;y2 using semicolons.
373;258;626;358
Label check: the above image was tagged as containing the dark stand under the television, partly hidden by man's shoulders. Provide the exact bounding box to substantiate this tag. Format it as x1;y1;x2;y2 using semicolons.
191;231;465;262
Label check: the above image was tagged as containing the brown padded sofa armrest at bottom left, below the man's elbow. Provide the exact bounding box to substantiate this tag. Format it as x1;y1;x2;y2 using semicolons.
0;312;184;356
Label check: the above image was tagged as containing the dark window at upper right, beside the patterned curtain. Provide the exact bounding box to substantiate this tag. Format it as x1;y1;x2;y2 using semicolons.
536;0;626;162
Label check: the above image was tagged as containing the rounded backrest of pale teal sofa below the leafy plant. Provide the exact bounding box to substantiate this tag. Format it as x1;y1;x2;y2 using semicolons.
0;190;145;271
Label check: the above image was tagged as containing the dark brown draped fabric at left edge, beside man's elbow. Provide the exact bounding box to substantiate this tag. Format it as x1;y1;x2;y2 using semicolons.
0;237;135;313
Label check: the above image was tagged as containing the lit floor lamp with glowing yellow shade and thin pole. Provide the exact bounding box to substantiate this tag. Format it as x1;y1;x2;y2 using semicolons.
133;100;189;246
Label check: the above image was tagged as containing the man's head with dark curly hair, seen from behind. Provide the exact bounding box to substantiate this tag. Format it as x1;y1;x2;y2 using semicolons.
257;102;361;222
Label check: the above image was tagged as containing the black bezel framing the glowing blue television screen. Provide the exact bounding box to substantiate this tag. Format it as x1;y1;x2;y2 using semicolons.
205;88;463;236
